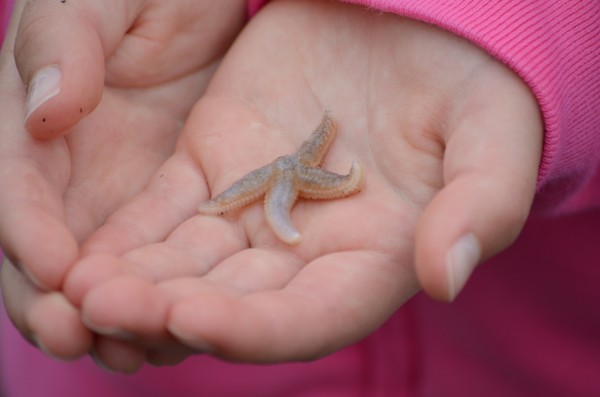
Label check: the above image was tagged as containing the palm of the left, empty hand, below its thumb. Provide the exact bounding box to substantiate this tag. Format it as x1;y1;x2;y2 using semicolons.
63;89;181;240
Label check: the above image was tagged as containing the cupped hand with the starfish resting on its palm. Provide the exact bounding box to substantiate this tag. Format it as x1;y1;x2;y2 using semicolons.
65;1;542;366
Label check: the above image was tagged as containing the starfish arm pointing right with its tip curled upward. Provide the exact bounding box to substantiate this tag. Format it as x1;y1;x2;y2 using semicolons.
296;161;365;200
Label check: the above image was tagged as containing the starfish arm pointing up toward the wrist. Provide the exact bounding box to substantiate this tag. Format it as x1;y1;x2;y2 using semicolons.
295;111;337;167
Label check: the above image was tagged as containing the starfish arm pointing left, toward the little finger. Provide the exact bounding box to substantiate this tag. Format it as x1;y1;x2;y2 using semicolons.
198;164;273;215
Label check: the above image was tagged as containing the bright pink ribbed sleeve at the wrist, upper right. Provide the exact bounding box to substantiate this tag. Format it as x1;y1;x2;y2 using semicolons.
249;0;600;211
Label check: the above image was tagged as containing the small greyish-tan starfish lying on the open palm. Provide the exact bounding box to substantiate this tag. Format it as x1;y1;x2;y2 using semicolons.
198;112;365;244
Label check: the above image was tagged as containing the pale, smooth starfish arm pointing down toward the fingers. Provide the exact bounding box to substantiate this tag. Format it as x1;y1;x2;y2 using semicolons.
265;171;300;244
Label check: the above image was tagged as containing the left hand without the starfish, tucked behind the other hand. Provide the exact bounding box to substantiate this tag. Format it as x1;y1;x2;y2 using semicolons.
0;0;245;366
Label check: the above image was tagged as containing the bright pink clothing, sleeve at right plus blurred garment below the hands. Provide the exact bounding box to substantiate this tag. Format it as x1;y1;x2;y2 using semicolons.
0;0;600;397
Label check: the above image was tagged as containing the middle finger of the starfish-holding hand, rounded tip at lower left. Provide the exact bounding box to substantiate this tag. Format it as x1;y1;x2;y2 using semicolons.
82;250;360;363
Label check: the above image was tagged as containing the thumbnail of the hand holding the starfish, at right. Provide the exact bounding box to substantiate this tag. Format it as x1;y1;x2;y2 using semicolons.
446;233;481;301
